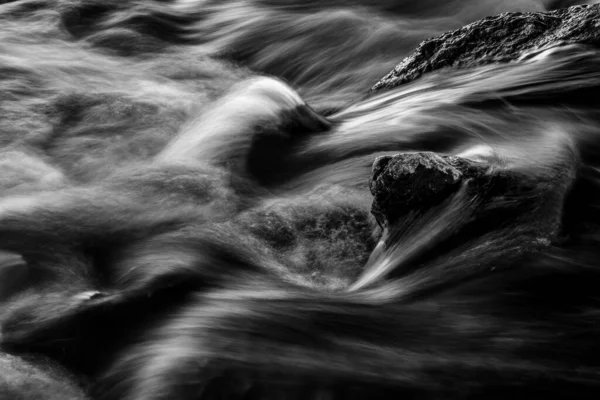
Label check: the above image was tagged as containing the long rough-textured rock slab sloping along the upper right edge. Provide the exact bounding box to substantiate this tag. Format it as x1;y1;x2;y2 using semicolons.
371;4;600;91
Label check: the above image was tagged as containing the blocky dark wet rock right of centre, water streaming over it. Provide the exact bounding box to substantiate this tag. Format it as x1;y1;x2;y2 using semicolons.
369;152;578;260
